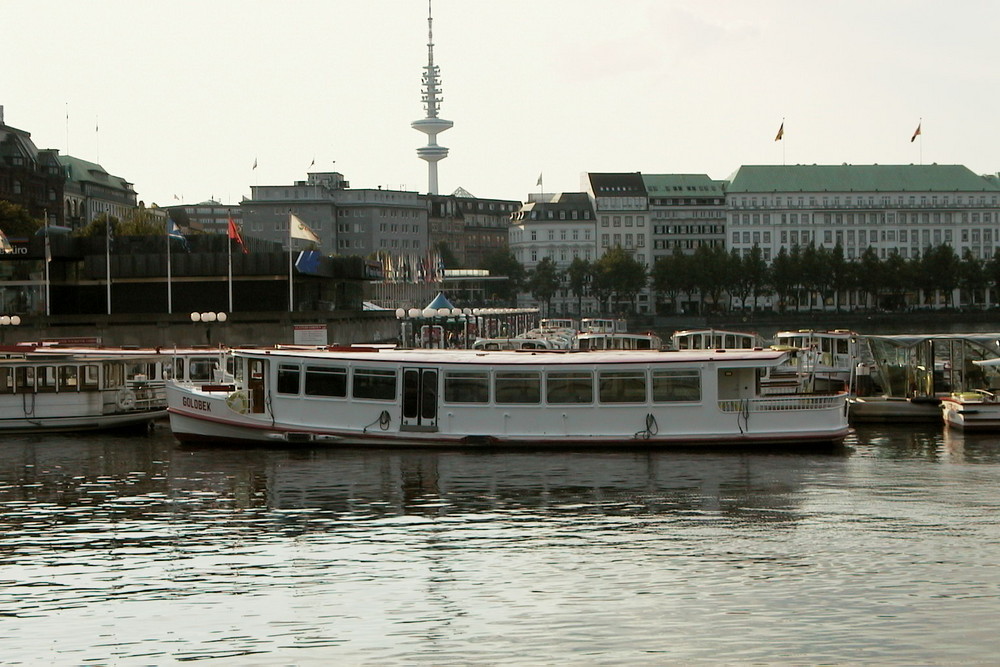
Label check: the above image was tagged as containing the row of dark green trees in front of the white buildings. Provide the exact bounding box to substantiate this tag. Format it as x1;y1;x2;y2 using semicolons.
480;244;1000;314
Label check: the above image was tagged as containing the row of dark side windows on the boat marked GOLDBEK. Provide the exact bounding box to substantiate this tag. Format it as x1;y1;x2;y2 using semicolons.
276;364;701;405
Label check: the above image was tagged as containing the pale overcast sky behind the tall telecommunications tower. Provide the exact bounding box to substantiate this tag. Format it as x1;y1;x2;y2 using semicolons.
0;0;1000;206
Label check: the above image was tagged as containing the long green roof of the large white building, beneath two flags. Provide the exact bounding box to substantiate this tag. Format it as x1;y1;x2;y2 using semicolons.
728;164;1000;194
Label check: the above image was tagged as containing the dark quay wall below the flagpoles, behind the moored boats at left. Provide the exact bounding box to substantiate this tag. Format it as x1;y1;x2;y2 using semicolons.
0;311;399;348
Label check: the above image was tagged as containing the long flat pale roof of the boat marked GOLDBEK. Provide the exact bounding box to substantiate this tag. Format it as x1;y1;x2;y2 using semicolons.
233;347;788;366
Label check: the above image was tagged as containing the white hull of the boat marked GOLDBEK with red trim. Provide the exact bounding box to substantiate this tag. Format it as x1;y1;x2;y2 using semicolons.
167;384;850;446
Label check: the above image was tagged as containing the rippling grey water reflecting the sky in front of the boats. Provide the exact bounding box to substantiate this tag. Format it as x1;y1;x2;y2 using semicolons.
0;427;1000;664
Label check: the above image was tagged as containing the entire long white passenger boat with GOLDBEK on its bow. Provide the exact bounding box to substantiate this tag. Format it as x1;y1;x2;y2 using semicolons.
167;347;849;446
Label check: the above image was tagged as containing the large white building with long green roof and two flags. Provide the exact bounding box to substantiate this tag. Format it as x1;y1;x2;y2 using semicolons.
726;164;1000;261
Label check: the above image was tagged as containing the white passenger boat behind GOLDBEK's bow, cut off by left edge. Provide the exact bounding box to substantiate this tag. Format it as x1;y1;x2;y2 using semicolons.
0;351;166;432
